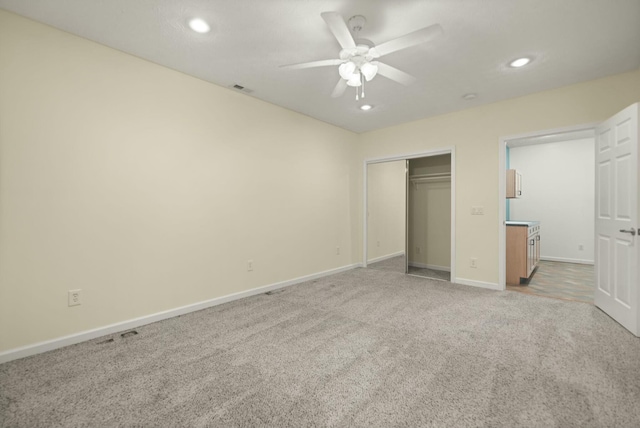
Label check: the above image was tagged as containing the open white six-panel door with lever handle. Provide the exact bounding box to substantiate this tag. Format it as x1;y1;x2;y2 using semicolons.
594;104;640;336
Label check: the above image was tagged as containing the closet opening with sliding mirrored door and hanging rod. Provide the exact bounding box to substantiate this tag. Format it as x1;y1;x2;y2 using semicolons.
363;148;455;282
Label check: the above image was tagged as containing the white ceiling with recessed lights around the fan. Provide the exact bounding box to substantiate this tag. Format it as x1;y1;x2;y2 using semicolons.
0;0;640;132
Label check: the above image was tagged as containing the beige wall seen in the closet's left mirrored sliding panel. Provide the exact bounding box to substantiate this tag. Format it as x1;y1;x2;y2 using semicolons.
367;161;406;261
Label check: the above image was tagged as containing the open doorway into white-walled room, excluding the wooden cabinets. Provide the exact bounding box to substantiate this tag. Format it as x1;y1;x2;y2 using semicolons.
505;131;595;304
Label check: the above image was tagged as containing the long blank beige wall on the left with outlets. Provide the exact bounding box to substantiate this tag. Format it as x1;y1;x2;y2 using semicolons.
0;11;360;351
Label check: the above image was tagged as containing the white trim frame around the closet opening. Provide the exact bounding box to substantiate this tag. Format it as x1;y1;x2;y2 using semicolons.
362;146;456;282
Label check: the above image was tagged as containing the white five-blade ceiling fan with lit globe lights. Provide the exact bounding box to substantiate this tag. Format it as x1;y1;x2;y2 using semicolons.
281;12;442;100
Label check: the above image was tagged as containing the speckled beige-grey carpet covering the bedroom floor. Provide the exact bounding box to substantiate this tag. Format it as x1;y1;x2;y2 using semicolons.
0;269;640;427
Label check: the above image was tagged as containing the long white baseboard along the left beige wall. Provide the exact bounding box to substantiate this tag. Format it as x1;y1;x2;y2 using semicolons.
0;263;360;364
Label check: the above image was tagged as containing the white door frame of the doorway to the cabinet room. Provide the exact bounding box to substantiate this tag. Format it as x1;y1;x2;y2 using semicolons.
498;122;600;291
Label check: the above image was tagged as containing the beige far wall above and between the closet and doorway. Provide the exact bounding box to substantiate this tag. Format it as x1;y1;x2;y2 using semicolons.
359;70;640;284
